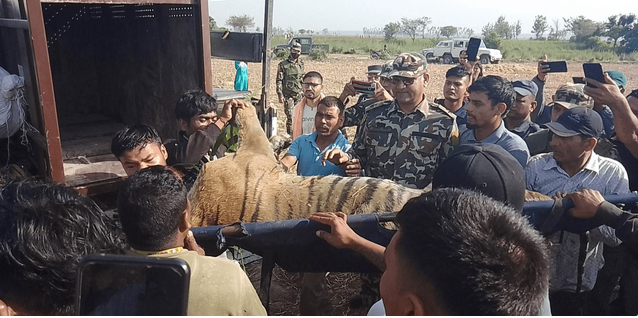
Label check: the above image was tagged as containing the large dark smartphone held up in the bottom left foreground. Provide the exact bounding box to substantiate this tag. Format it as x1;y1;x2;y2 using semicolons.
75;254;190;316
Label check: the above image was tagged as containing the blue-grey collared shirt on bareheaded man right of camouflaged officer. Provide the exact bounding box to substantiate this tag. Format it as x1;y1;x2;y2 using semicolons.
461;120;529;168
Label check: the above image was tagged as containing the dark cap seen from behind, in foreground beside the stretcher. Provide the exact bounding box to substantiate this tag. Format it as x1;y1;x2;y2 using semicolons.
432;143;525;212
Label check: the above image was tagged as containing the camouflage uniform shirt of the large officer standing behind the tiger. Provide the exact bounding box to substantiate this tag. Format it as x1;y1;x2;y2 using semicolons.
349;96;458;189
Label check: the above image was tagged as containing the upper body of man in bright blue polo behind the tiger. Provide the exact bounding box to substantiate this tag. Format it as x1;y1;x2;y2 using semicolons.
281;96;351;176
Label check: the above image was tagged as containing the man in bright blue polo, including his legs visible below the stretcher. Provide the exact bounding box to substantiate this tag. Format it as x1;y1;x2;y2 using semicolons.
281;96;351;316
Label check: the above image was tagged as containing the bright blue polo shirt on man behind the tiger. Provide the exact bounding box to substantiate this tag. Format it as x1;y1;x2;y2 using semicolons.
288;131;352;176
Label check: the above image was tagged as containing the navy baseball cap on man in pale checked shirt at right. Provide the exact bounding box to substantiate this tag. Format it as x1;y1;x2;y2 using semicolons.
545;107;603;138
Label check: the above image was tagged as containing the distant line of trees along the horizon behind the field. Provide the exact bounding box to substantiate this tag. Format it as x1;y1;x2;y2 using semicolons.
209;13;638;54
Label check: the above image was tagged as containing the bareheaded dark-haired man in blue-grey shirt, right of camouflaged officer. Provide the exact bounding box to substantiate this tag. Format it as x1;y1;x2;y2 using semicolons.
460;76;529;167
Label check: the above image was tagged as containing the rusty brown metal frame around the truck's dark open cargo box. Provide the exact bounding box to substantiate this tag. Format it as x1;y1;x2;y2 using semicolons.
0;0;212;194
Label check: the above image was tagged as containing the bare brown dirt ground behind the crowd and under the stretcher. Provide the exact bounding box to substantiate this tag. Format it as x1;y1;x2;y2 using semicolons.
212;54;638;316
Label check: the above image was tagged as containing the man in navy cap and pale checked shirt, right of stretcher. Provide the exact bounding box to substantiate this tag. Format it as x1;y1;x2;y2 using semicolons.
525;107;629;316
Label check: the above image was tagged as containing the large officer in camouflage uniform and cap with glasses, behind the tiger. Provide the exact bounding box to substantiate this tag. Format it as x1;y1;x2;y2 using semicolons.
324;53;459;189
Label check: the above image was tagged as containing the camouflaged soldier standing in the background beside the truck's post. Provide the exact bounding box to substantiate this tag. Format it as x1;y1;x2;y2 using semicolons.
277;42;304;135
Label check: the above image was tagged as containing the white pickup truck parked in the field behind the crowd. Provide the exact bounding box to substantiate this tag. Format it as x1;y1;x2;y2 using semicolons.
423;39;503;64
